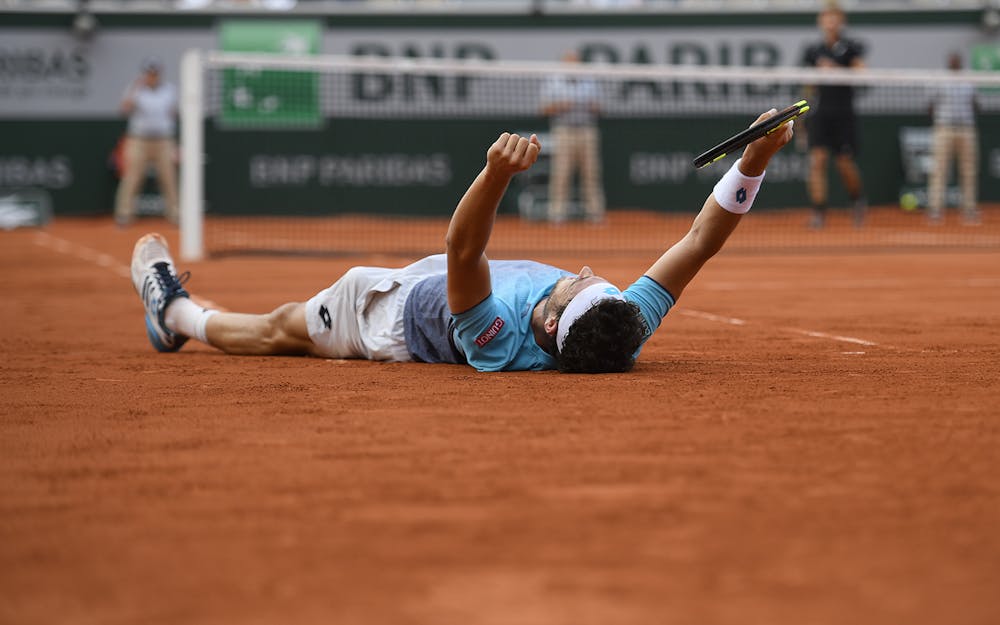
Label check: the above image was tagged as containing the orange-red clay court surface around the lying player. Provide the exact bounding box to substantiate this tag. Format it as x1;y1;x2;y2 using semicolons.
0;210;1000;625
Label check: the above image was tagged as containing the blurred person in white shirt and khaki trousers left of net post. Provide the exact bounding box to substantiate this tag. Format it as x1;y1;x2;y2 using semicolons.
115;59;177;226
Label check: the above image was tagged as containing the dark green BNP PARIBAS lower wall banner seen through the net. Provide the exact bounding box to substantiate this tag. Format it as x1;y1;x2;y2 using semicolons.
205;115;1000;218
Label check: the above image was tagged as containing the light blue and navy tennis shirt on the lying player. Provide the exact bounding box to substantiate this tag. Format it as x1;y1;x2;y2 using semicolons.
403;261;674;371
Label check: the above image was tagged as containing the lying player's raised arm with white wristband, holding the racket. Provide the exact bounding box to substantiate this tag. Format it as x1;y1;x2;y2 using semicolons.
646;109;794;298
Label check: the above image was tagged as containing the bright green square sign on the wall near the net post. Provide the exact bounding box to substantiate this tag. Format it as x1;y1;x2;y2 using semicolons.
219;20;323;129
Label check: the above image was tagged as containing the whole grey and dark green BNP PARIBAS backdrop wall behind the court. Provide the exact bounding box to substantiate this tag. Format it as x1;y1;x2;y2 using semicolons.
0;3;1000;216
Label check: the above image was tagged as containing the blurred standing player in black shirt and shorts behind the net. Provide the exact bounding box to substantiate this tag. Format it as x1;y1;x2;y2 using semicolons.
803;3;867;228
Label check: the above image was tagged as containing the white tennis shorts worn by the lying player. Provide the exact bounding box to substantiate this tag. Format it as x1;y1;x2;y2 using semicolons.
306;254;448;362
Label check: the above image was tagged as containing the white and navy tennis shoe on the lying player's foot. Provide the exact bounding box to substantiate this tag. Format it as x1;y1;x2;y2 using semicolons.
132;233;191;352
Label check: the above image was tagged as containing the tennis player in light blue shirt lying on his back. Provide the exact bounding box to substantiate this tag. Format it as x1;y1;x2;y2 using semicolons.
132;109;794;373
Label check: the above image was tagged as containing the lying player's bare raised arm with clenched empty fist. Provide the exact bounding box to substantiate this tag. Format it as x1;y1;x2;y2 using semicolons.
446;132;542;313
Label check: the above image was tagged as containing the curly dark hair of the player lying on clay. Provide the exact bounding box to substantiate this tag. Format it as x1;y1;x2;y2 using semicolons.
556;299;647;373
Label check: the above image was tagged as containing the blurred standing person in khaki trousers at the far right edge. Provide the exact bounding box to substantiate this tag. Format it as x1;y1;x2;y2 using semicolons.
927;52;980;225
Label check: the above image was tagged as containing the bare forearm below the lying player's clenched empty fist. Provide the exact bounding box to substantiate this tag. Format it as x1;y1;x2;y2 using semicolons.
445;165;512;261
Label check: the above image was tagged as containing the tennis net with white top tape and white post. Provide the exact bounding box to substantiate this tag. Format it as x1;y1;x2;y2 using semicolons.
182;51;1000;258
